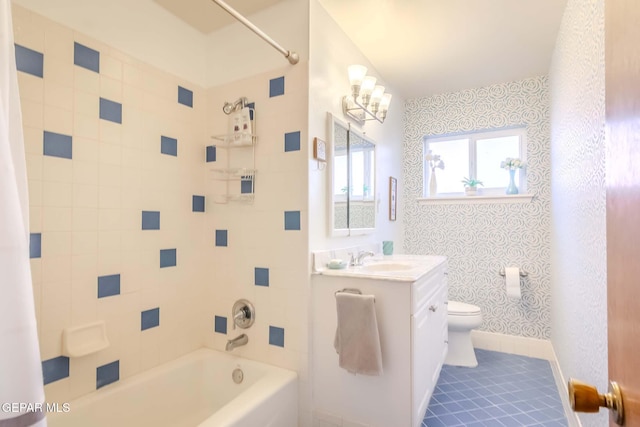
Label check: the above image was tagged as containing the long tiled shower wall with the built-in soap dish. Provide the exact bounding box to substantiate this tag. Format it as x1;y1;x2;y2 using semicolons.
13;5;211;402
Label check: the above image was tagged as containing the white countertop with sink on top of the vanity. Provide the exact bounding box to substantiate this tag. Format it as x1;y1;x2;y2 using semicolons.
316;255;447;282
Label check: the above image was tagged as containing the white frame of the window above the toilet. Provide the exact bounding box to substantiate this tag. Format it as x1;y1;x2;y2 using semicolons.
422;126;527;199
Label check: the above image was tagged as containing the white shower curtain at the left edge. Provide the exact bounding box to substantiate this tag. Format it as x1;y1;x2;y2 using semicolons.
0;0;47;427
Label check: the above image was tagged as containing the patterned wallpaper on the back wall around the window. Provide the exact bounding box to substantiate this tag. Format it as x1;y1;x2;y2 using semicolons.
402;76;551;339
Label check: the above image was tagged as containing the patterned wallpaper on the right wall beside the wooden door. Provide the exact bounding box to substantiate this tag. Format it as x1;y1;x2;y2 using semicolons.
549;0;607;426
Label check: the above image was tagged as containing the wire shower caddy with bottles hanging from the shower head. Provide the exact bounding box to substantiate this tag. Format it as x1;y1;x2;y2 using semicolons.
210;103;258;203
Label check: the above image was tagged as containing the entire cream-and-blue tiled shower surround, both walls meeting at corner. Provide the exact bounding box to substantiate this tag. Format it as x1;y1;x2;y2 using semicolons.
14;6;310;416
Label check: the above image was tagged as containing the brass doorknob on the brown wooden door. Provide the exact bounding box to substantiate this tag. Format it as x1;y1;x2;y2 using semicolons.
568;378;624;425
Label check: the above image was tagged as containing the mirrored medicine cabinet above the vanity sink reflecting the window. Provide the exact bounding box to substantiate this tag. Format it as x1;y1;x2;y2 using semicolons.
329;114;376;236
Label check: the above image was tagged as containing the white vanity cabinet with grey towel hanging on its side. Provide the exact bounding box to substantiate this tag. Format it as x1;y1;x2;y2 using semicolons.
311;257;447;427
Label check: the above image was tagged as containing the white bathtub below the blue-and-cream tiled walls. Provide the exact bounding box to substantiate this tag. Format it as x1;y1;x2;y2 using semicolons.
48;349;298;427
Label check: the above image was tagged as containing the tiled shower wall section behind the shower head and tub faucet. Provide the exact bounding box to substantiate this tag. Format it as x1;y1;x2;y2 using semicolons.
202;67;309;425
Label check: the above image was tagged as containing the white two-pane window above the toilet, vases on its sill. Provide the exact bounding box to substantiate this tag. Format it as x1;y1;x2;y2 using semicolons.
423;128;527;197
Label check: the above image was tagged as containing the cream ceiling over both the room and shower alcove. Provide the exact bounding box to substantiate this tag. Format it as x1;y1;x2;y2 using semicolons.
154;0;567;98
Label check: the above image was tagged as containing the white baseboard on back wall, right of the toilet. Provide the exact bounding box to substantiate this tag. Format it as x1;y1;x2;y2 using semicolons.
471;331;555;360
